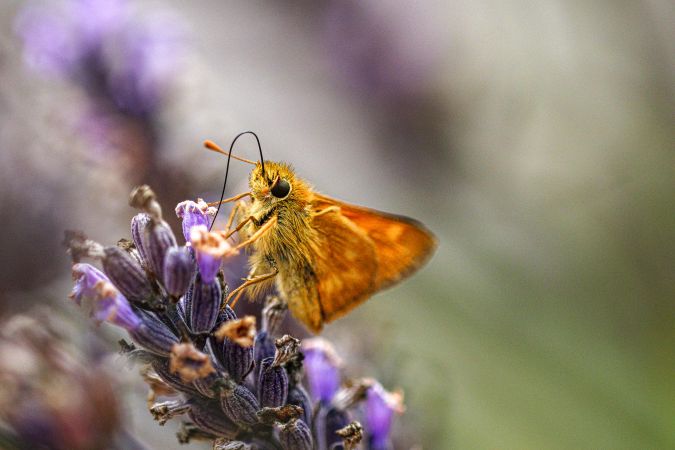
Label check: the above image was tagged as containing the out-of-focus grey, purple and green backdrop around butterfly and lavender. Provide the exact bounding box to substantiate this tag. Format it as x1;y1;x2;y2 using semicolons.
0;0;675;449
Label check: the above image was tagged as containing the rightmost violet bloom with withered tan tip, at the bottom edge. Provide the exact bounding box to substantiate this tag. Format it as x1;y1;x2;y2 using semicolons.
366;382;403;450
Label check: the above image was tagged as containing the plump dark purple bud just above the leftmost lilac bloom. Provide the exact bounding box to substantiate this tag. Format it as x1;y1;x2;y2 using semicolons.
103;247;152;303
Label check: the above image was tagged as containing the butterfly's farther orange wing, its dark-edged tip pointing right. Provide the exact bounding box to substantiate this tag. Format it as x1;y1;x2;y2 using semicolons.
312;193;437;292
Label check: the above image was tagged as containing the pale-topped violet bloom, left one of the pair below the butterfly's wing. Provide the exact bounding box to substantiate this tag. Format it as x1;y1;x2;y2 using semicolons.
303;338;342;403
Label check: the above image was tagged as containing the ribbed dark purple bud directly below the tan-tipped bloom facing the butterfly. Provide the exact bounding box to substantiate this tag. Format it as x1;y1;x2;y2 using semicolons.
184;274;223;334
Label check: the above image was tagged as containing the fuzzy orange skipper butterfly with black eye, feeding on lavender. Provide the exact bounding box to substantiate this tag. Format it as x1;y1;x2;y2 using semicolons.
205;132;437;333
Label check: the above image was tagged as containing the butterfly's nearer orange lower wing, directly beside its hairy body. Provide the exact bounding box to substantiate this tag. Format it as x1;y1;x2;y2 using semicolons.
302;207;377;332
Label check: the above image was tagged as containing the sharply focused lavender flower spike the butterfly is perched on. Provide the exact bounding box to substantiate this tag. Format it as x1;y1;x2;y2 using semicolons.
69;186;410;450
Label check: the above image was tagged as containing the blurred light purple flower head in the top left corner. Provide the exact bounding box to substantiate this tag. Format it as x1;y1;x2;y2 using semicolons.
15;0;185;115
